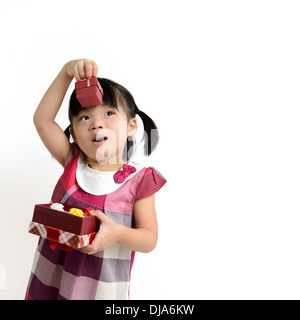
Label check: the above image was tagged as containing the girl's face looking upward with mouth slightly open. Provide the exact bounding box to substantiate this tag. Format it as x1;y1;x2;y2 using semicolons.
70;104;137;164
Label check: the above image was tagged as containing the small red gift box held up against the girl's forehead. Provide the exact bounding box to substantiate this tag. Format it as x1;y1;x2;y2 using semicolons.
75;78;103;107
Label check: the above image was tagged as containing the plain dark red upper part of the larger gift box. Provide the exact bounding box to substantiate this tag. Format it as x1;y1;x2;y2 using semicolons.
32;203;100;235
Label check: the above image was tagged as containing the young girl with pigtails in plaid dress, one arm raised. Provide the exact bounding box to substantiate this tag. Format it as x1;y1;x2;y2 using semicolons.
26;59;166;300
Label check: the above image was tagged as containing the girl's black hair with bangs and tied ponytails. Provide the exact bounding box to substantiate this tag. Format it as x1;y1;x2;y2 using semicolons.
65;78;159;160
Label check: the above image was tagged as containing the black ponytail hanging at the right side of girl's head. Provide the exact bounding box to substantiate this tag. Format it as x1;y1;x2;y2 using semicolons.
136;110;159;156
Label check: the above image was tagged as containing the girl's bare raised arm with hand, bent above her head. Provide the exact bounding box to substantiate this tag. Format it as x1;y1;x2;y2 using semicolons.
33;59;98;166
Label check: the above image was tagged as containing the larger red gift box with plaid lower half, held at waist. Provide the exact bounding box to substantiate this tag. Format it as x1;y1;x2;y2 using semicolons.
28;203;99;250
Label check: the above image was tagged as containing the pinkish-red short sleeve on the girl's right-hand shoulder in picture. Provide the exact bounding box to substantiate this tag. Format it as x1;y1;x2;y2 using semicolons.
135;167;167;200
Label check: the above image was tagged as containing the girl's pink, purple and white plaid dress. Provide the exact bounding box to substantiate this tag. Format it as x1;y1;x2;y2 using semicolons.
25;143;166;300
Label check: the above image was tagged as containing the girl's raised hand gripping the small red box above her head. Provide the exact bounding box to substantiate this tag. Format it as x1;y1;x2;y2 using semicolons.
64;59;98;81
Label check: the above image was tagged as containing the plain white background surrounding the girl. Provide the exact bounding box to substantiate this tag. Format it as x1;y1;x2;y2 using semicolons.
0;0;300;299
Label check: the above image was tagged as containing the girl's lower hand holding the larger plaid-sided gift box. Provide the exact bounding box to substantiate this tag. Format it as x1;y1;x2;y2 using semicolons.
83;210;120;254
